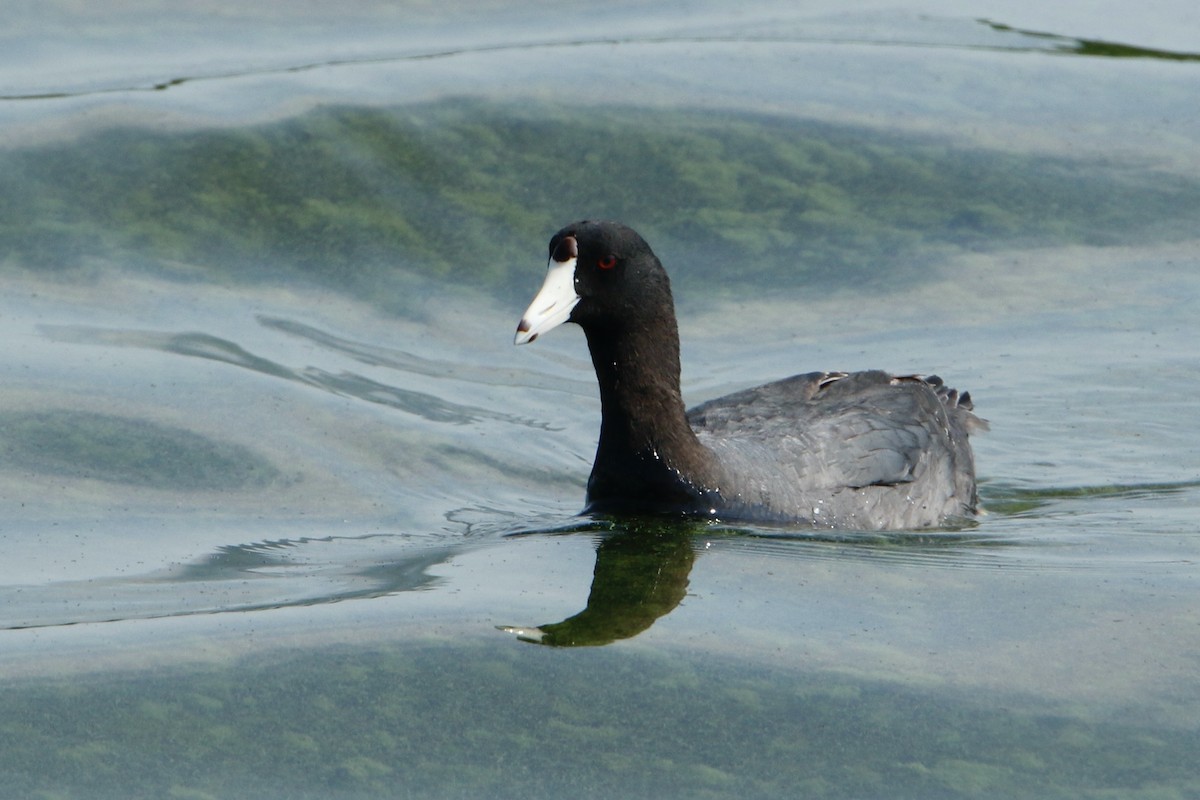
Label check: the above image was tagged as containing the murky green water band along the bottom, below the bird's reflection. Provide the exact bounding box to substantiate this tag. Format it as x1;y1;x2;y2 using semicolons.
0;639;1200;800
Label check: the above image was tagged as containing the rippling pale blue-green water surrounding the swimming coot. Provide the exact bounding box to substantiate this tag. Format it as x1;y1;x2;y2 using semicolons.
0;2;1200;798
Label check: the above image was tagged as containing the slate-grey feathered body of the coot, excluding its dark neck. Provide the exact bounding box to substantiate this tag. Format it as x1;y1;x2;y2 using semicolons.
688;372;983;530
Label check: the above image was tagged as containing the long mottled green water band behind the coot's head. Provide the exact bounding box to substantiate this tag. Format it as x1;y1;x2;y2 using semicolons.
0;101;1200;307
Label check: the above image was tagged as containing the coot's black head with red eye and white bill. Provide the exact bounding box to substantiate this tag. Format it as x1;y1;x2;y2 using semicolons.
516;219;674;344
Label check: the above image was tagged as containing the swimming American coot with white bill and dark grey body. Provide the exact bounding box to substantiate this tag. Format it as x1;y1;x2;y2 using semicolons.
516;221;984;530
